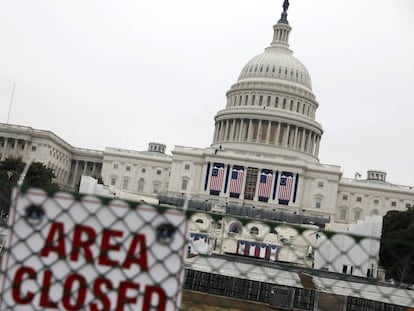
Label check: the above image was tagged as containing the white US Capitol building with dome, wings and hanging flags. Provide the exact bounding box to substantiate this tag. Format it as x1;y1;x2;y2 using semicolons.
0;6;414;227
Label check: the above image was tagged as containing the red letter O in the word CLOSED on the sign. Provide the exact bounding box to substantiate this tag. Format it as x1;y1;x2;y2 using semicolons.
62;274;88;311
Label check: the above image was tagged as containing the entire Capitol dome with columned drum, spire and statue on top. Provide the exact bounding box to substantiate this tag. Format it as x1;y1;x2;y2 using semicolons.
212;0;323;162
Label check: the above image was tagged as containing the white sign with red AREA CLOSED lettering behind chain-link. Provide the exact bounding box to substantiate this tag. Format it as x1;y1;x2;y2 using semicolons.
0;189;187;311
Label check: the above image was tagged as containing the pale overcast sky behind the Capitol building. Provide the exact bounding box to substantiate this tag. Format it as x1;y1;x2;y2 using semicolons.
0;0;414;185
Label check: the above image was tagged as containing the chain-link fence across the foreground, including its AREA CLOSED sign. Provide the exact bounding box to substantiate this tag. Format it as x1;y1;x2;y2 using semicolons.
0;185;414;311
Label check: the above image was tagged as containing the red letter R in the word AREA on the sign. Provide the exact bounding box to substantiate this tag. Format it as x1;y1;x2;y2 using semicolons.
70;225;96;262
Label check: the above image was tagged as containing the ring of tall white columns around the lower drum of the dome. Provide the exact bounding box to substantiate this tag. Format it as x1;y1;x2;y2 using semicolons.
214;119;321;156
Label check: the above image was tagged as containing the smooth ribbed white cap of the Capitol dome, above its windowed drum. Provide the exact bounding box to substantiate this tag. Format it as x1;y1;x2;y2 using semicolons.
238;47;312;89
